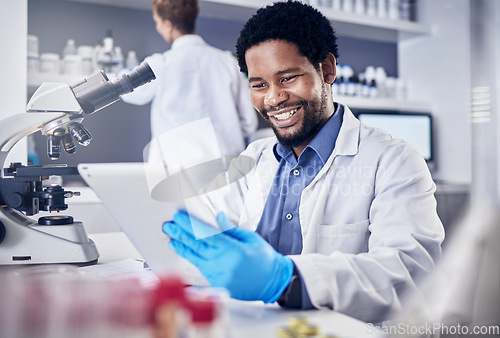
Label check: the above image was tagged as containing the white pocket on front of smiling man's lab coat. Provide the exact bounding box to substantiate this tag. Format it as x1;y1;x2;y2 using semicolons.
317;220;370;255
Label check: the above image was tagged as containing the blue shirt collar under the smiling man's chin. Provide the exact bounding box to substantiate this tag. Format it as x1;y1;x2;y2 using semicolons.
273;103;344;164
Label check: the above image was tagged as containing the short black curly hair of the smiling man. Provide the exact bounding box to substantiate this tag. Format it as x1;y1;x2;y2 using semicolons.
236;1;338;75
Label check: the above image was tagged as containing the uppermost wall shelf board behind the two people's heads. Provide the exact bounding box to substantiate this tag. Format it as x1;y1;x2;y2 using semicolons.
66;0;432;42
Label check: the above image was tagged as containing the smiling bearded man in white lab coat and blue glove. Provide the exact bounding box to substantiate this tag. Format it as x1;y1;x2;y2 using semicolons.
163;1;444;322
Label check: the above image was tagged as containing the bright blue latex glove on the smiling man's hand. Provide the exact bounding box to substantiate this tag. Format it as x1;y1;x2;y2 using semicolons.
163;211;293;303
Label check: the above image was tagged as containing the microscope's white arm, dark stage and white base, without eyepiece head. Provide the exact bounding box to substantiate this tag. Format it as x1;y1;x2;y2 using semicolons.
0;112;99;265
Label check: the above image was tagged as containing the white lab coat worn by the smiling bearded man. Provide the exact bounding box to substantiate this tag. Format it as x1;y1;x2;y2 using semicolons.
205;107;444;322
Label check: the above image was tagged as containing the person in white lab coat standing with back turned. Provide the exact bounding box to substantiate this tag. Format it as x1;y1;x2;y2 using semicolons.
122;0;258;160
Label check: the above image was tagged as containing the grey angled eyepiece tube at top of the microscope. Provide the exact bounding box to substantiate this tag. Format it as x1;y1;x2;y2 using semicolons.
71;63;156;114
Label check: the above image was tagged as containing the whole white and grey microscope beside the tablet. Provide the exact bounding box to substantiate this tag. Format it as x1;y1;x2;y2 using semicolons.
0;63;155;265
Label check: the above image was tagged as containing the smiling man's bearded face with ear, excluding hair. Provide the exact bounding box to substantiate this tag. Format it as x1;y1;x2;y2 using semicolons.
245;40;335;157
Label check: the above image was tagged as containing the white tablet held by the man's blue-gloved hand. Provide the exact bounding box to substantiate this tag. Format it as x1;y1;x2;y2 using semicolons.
78;163;214;285
